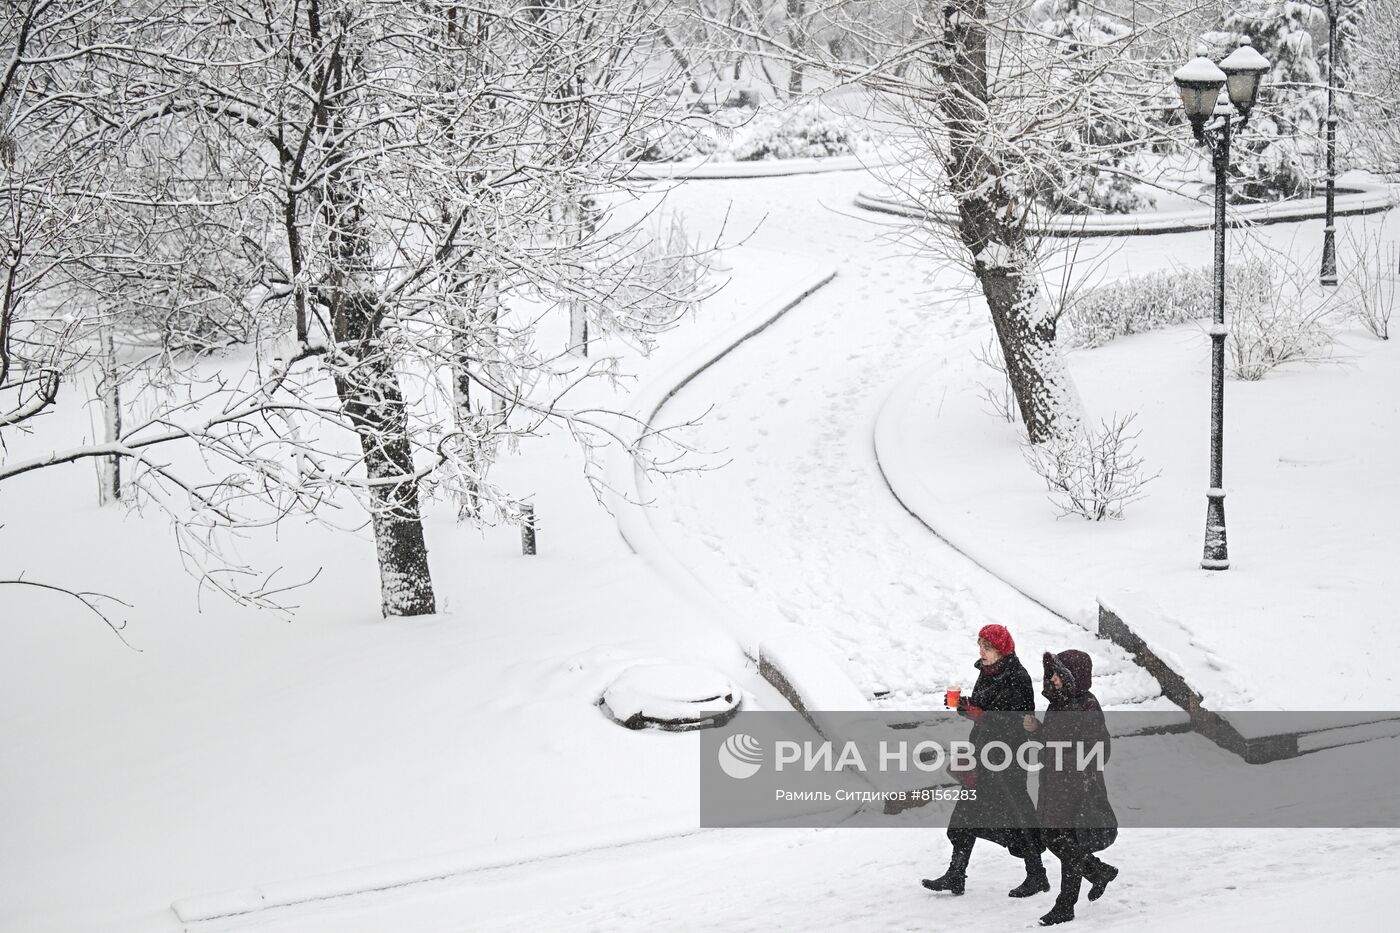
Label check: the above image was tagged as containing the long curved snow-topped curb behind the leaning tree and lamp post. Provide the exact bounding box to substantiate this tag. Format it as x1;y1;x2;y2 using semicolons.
855;181;1396;237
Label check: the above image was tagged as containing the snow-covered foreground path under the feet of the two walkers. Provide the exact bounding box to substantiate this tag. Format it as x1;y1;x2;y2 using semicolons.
215;829;1400;933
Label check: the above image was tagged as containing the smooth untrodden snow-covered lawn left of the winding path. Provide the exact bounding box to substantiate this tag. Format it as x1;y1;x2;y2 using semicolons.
0;232;813;933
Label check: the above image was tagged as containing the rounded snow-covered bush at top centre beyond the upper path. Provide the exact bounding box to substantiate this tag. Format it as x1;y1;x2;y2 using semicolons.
633;102;874;163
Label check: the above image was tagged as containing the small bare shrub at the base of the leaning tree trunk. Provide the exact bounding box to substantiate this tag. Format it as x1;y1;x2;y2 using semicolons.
1021;413;1159;521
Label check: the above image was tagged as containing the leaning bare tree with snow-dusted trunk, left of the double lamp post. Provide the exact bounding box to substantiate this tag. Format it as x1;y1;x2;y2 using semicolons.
705;0;1190;443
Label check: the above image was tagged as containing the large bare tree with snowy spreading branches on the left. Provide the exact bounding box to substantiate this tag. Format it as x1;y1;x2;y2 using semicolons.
0;0;711;615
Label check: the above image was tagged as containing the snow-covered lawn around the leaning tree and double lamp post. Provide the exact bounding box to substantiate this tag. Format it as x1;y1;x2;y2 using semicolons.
876;200;1400;710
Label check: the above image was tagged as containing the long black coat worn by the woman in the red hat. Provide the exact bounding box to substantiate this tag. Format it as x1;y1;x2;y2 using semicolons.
948;654;1044;857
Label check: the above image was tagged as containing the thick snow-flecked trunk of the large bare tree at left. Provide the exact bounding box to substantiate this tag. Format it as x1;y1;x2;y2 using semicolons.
335;296;437;618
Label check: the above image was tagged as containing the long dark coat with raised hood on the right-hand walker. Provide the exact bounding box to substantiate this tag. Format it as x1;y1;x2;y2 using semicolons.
1036;650;1119;852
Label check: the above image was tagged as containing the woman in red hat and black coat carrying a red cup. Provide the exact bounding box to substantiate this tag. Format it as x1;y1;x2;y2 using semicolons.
923;625;1050;898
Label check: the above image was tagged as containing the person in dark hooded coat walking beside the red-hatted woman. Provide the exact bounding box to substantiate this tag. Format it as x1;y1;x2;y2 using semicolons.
1025;650;1119;926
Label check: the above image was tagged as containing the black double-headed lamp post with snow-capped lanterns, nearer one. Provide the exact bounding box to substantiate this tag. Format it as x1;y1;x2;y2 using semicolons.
1173;39;1268;570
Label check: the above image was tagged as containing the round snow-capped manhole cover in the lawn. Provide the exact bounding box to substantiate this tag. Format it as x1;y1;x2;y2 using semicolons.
598;663;742;731
